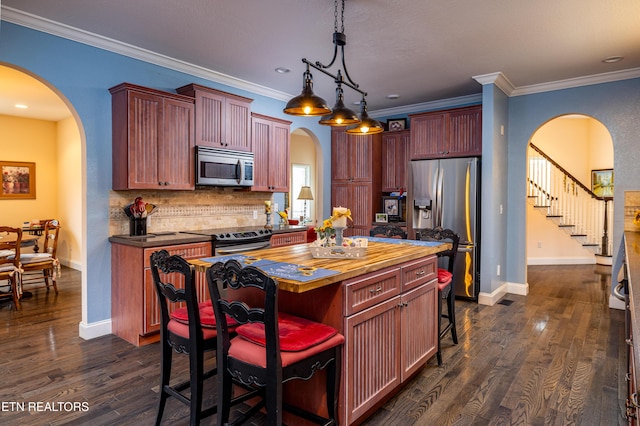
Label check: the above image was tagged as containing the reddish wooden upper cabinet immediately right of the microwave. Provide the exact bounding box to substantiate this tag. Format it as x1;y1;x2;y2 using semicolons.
251;113;291;192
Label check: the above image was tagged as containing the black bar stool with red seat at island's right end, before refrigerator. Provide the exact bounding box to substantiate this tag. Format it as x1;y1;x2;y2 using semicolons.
416;228;460;365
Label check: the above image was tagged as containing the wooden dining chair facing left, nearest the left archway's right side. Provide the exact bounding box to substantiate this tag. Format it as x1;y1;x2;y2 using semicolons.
20;219;60;294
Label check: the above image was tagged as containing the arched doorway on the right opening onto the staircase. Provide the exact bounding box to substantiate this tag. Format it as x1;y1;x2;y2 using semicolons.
526;114;613;265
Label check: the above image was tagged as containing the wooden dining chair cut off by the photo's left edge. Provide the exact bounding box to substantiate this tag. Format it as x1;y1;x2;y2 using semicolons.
0;226;22;309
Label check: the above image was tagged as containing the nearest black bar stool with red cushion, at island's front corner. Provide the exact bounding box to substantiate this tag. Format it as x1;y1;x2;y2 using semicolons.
207;260;344;426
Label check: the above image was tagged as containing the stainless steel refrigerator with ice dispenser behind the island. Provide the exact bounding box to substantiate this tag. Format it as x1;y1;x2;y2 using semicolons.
407;157;480;300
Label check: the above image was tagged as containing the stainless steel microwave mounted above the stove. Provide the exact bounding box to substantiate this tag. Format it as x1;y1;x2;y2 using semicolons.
196;146;253;186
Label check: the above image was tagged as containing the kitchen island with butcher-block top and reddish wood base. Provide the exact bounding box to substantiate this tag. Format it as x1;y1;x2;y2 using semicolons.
191;240;450;425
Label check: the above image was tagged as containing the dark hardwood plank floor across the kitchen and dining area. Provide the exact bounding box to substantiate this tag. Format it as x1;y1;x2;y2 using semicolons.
0;265;626;426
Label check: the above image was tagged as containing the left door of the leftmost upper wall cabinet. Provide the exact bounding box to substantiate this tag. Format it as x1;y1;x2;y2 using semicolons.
128;92;163;189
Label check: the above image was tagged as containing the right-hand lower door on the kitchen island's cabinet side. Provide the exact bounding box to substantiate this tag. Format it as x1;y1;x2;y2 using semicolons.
401;280;438;381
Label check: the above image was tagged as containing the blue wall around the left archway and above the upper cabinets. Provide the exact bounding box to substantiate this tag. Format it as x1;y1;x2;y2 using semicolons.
0;21;331;324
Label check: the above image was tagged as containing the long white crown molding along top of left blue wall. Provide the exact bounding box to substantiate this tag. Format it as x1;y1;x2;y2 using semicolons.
0;6;293;102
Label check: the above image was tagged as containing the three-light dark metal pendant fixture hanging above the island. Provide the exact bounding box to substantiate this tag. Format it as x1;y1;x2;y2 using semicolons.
284;0;383;135
